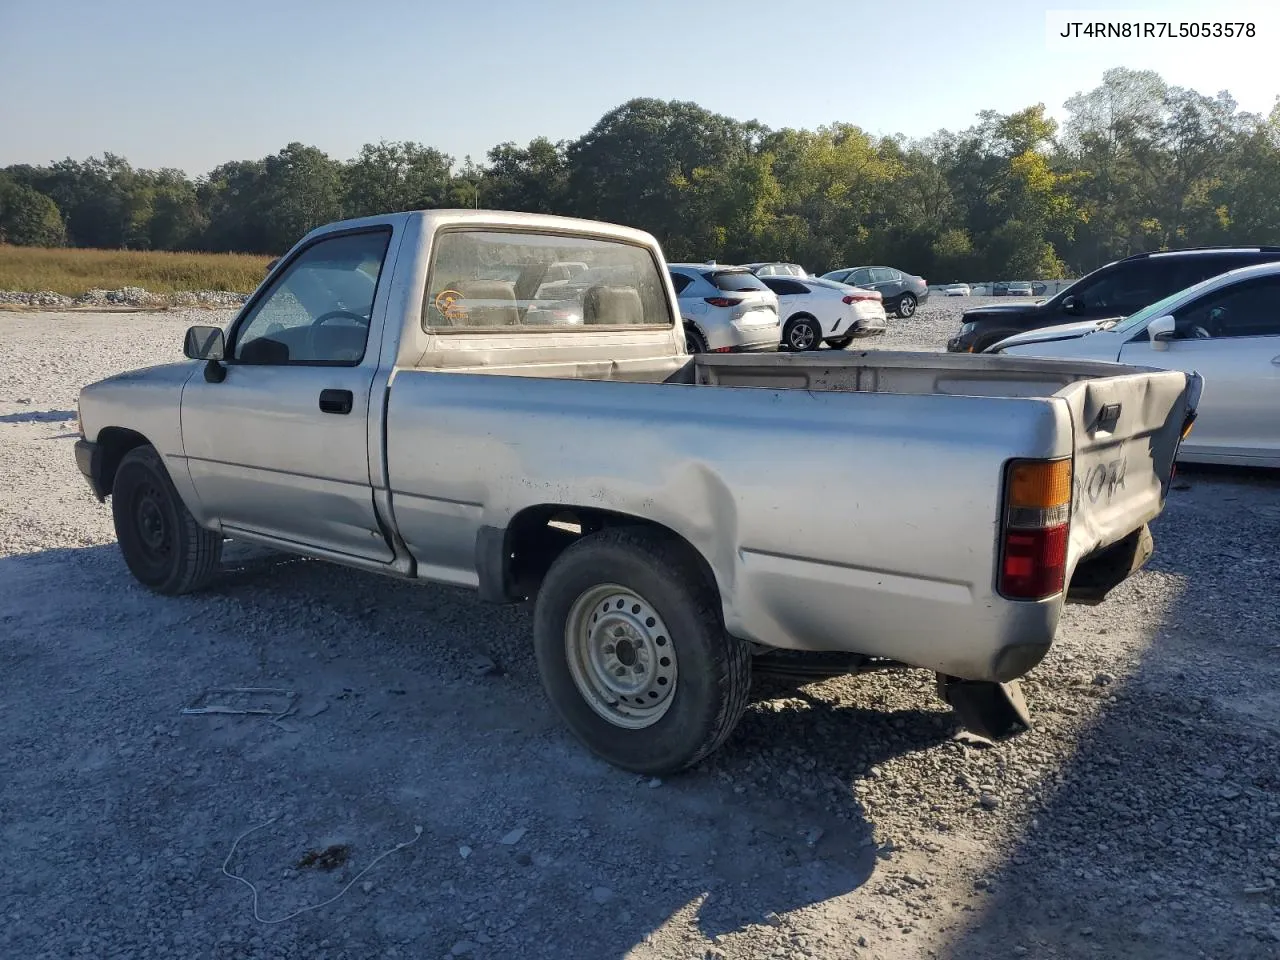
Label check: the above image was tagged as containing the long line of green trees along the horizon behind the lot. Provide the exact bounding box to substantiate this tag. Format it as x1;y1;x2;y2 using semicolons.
0;68;1280;282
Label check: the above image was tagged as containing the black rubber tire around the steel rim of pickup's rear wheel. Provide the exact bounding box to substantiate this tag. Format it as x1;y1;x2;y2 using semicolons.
534;527;751;776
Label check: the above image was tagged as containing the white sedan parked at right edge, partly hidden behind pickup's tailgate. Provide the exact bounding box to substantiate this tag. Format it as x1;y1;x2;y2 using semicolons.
987;262;1280;467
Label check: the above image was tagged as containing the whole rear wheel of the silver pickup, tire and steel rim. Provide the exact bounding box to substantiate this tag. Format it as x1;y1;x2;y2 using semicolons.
534;527;751;776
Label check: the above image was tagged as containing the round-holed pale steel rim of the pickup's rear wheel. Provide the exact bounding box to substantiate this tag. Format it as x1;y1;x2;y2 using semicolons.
564;584;678;730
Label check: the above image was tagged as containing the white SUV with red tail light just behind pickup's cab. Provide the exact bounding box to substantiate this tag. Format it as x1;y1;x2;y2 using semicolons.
667;264;782;353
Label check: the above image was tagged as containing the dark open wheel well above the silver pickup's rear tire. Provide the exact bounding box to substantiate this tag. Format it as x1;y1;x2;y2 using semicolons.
494;512;719;603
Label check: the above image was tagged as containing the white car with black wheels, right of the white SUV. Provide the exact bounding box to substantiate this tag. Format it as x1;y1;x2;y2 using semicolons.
760;276;887;351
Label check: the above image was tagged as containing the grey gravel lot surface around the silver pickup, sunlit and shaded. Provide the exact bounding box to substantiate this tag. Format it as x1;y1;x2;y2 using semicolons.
0;305;1280;960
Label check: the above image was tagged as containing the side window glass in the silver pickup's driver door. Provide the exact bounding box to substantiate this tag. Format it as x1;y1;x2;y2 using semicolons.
230;228;392;366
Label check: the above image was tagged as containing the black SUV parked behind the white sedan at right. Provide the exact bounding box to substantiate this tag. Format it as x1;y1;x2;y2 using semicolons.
947;247;1280;353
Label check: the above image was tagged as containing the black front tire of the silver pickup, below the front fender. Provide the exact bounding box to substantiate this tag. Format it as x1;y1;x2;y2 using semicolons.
111;445;223;596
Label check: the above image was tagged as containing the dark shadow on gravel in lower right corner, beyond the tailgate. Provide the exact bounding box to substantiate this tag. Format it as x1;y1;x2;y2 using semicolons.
940;468;1280;960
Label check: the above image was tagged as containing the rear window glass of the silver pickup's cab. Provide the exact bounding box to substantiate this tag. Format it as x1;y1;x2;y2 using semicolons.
422;230;673;330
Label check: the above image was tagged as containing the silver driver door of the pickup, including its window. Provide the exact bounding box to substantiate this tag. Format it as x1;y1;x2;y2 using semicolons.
182;227;393;562
